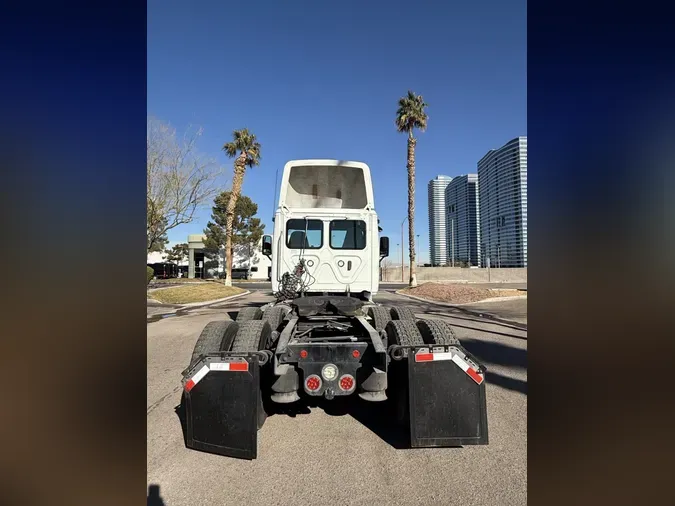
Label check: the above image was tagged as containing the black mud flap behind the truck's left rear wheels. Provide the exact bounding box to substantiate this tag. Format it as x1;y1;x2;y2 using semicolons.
183;354;262;459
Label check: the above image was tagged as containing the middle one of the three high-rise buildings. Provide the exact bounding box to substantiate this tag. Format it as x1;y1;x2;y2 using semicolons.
445;174;480;266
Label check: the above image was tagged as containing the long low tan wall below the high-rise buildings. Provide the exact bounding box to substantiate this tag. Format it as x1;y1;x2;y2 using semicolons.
382;265;527;283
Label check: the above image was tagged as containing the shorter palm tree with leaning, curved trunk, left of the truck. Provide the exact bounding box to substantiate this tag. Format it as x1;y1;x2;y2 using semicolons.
223;128;260;286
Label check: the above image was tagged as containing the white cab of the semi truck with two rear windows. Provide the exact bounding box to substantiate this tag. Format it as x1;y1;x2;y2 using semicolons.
263;160;389;299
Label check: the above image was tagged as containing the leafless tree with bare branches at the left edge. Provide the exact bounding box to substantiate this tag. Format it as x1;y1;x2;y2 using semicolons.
147;117;224;251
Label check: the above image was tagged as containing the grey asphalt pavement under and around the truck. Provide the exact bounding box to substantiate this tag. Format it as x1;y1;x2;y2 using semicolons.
147;290;527;506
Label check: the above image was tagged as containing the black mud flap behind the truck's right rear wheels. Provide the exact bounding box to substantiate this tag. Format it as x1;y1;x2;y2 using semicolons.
408;346;488;448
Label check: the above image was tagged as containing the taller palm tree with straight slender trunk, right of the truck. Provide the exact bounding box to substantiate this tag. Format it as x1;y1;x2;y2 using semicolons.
396;91;429;287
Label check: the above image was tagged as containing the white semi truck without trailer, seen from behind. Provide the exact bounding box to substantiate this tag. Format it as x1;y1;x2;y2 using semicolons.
182;160;488;459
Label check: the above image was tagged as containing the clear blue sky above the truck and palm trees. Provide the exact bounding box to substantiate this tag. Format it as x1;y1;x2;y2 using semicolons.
147;0;527;261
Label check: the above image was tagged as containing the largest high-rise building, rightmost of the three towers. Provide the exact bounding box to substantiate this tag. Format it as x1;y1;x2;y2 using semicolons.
478;137;527;267
